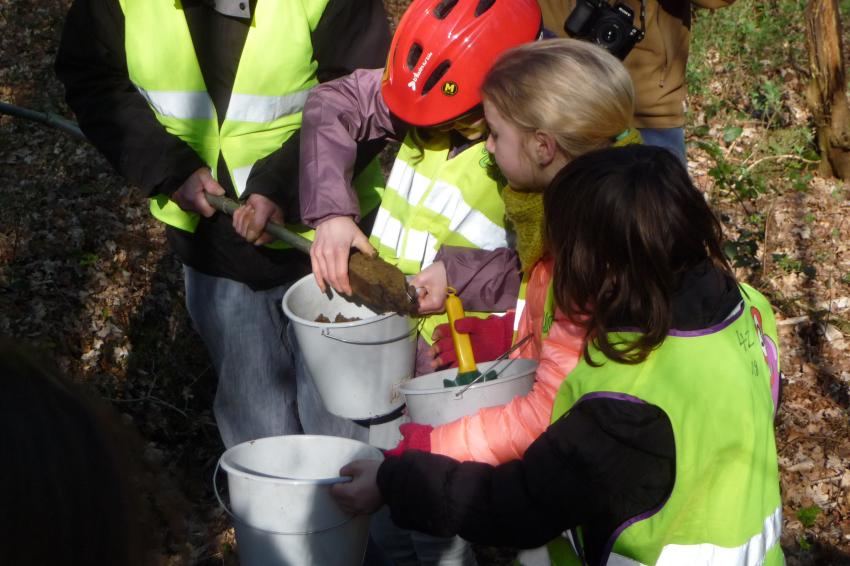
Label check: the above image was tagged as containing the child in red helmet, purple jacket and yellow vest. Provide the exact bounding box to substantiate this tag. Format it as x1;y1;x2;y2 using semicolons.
298;0;541;565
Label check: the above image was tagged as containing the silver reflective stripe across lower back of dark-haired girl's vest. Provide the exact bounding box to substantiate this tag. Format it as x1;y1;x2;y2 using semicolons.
648;505;782;566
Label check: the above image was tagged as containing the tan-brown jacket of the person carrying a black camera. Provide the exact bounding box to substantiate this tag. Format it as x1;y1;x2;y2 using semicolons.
538;0;735;128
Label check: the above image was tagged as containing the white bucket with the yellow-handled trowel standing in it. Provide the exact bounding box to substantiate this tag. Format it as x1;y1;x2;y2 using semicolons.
399;358;537;426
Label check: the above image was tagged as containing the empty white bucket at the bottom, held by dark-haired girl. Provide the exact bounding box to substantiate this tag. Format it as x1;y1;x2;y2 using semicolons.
213;435;383;566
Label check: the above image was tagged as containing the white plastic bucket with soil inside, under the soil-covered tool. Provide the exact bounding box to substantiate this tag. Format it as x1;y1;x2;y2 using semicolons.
283;275;417;420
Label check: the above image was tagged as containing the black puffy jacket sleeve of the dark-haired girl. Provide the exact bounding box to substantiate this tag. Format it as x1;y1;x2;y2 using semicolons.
378;398;675;558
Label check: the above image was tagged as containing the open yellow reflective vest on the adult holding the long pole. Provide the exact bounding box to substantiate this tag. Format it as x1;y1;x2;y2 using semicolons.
120;0;382;242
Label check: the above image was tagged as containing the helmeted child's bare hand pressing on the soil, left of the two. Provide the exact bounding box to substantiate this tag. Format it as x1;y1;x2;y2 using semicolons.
310;216;377;295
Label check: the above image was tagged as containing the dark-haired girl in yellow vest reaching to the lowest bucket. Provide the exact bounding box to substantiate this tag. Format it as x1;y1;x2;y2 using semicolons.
334;146;784;565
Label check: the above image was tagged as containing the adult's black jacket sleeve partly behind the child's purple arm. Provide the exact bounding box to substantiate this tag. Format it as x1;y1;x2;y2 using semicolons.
245;0;390;210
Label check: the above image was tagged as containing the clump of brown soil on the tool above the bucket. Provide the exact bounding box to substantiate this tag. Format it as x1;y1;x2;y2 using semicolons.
348;252;419;316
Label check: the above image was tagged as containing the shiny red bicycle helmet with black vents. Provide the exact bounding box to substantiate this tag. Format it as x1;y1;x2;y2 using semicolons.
381;0;541;126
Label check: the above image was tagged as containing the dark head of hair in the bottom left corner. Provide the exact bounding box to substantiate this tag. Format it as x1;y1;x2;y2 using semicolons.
0;337;147;566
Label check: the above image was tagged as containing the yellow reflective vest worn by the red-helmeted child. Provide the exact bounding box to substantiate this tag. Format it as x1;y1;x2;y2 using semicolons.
369;132;508;343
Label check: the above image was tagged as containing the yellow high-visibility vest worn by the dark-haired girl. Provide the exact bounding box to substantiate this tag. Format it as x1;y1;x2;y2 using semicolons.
549;285;784;566
